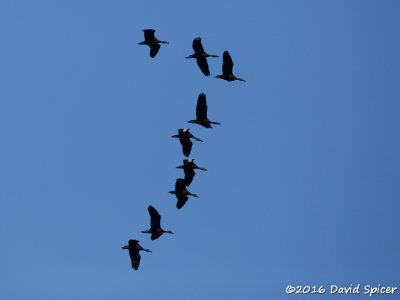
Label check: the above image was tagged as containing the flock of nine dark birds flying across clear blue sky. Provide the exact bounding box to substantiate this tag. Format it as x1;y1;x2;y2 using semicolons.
122;29;245;270
